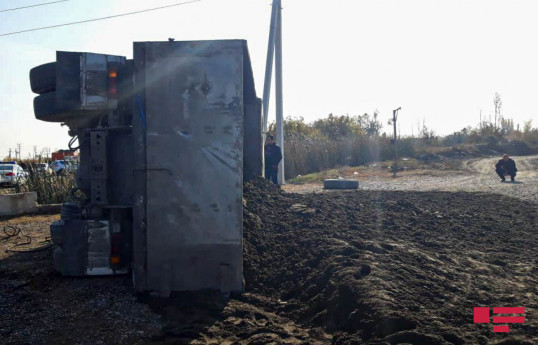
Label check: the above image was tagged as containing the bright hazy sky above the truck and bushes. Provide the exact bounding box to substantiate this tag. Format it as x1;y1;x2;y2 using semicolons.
0;0;538;158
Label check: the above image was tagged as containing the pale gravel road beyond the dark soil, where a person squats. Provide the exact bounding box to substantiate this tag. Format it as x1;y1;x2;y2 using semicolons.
283;155;538;203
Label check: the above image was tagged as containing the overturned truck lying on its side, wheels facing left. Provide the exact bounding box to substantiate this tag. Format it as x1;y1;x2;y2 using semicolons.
30;40;263;296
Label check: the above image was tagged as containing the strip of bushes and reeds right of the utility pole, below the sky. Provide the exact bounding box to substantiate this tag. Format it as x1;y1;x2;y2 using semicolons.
269;113;538;179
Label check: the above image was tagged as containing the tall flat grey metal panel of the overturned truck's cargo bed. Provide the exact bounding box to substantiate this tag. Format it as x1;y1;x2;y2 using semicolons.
135;41;245;296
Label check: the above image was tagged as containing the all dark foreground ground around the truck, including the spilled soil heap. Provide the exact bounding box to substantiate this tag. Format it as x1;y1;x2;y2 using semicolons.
0;179;538;345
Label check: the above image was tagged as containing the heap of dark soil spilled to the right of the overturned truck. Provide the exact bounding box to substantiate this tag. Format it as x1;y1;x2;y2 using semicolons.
244;181;538;344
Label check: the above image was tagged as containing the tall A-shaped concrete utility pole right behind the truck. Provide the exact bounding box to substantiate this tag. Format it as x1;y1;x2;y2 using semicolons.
263;0;286;184
